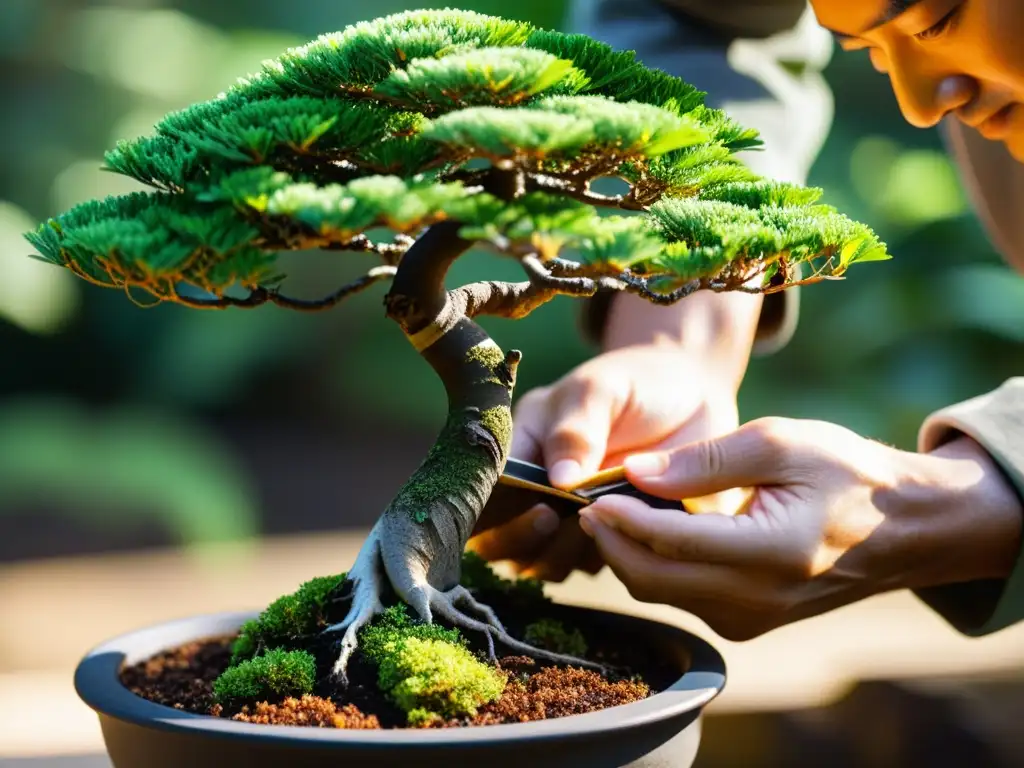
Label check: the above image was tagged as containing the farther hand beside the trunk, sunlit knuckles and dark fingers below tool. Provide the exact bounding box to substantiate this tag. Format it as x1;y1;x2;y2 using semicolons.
469;344;738;582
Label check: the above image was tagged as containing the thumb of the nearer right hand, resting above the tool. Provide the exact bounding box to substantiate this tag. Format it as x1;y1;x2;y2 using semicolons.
624;419;802;499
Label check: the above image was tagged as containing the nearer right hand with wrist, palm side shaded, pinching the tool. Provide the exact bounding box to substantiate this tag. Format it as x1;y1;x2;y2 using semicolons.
581;419;1022;640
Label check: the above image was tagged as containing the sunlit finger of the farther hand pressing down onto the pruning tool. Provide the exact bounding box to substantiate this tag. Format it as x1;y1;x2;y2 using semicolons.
541;379;616;487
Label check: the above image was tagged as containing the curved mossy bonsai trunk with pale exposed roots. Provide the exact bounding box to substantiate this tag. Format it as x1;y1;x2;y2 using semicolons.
328;215;597;680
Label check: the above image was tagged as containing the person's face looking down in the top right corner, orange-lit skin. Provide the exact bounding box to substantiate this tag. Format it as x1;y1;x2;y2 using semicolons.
811;0;1024;163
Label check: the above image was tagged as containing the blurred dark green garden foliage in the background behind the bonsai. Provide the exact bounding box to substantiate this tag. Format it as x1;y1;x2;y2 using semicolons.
0;0;1024;560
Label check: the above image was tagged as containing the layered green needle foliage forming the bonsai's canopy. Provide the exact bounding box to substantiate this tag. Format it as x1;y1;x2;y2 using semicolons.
26;9;889;303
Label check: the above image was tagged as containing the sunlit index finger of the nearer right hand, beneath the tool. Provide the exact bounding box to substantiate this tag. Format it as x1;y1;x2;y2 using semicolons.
581;495;805;569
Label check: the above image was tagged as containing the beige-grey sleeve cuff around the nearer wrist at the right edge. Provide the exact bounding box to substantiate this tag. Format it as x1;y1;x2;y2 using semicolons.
916;377;1024;637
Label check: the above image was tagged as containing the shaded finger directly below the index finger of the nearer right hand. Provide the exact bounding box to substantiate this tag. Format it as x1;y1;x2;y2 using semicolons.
581;517;770;608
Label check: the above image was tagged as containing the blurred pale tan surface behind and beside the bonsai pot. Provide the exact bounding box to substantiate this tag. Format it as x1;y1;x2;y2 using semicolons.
6;531;1024;768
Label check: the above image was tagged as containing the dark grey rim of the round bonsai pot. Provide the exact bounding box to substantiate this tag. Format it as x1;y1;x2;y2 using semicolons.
75;605;726;750
